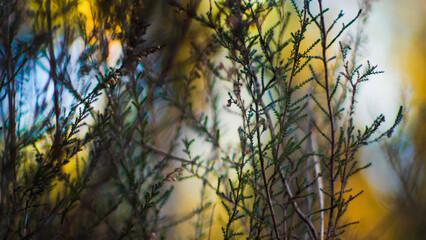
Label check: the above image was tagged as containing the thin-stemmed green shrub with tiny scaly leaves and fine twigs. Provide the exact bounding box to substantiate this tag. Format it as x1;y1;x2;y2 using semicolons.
0;0;402;239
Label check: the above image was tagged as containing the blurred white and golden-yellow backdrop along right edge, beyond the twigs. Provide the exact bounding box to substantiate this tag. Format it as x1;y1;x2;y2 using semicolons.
334;0;426;239
